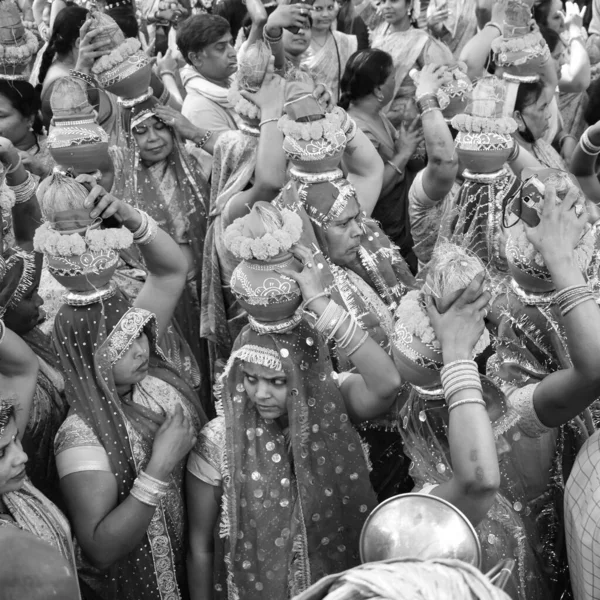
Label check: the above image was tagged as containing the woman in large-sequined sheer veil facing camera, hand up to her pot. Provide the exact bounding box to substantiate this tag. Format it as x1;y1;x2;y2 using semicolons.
188;204;400;600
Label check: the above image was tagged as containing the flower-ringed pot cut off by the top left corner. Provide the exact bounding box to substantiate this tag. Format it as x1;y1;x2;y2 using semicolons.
0;2;39;81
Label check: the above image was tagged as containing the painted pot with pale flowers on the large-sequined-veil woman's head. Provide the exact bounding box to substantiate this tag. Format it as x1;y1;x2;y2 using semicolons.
224;202;302;326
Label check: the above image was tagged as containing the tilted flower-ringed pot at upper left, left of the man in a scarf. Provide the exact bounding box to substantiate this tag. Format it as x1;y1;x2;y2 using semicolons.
90;12;152;99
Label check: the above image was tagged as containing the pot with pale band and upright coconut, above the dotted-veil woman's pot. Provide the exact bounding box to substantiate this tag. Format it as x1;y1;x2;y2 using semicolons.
48;77;110;174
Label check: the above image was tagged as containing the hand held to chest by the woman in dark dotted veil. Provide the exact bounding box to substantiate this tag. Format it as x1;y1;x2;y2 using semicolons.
146;404;196;481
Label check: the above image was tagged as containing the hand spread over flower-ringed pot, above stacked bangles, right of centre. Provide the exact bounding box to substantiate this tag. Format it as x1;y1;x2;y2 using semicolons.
426;271;491;362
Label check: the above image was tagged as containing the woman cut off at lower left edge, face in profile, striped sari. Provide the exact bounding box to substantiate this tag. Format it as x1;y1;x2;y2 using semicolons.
0;322;75;592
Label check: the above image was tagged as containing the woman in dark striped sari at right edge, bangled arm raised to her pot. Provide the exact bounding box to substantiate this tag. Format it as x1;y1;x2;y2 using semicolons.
487;185;600;598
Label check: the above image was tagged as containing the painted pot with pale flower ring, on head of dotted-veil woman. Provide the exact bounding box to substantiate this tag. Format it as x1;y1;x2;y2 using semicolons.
33;222;133;293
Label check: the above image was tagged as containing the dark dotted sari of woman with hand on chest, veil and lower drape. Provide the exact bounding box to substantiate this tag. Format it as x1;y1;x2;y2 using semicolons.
54;293;205;600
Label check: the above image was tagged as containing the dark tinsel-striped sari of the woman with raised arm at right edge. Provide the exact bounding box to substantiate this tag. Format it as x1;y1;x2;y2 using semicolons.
487;290;593;591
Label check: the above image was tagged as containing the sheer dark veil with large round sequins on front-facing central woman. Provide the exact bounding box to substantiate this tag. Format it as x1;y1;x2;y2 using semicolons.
220;323;375;600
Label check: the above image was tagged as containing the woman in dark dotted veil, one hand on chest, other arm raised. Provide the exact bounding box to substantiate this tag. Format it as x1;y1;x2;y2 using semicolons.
54;187;204;600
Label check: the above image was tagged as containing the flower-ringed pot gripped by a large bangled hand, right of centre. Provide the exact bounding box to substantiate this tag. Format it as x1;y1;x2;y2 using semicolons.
392;244;490;387
